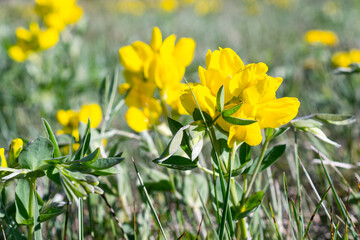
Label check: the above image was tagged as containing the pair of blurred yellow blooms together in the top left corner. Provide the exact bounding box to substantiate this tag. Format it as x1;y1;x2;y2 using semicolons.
8;0;82;62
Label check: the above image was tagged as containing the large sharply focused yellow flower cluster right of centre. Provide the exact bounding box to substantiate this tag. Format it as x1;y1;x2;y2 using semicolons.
181;48;300;147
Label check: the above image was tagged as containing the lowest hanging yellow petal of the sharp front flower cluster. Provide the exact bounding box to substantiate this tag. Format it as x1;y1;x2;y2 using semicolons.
228;123;262;147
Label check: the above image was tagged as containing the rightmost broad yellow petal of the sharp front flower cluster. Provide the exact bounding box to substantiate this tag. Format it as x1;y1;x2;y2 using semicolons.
256;97;300;128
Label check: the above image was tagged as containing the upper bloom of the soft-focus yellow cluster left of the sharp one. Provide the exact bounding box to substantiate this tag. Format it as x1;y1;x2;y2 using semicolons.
119;27;195;89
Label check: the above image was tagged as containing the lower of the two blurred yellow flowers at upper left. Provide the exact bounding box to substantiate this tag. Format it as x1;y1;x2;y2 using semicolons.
8;22;59;62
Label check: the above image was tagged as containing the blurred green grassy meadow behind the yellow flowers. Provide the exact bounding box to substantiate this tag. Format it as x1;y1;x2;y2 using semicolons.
0;0;360;238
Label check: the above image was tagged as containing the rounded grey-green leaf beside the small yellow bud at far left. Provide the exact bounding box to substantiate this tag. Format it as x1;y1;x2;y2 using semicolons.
19;137;54;170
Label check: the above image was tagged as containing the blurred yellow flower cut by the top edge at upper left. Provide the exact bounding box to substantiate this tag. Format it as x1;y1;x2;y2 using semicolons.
35;0;82;31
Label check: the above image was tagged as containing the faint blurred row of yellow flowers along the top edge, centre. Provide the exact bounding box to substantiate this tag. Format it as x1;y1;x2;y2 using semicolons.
117;0;223;15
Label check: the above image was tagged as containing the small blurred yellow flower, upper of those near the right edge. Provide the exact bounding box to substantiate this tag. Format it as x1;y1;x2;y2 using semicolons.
305;30;339;46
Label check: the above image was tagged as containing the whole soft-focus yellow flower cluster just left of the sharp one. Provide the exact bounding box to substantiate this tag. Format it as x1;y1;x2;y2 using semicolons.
119;27;195;132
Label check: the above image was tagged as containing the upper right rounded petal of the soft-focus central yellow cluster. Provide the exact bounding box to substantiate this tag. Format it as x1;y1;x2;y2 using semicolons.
174;38;196;67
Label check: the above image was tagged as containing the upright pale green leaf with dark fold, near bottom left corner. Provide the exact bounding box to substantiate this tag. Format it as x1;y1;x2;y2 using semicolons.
15;179;30;224
